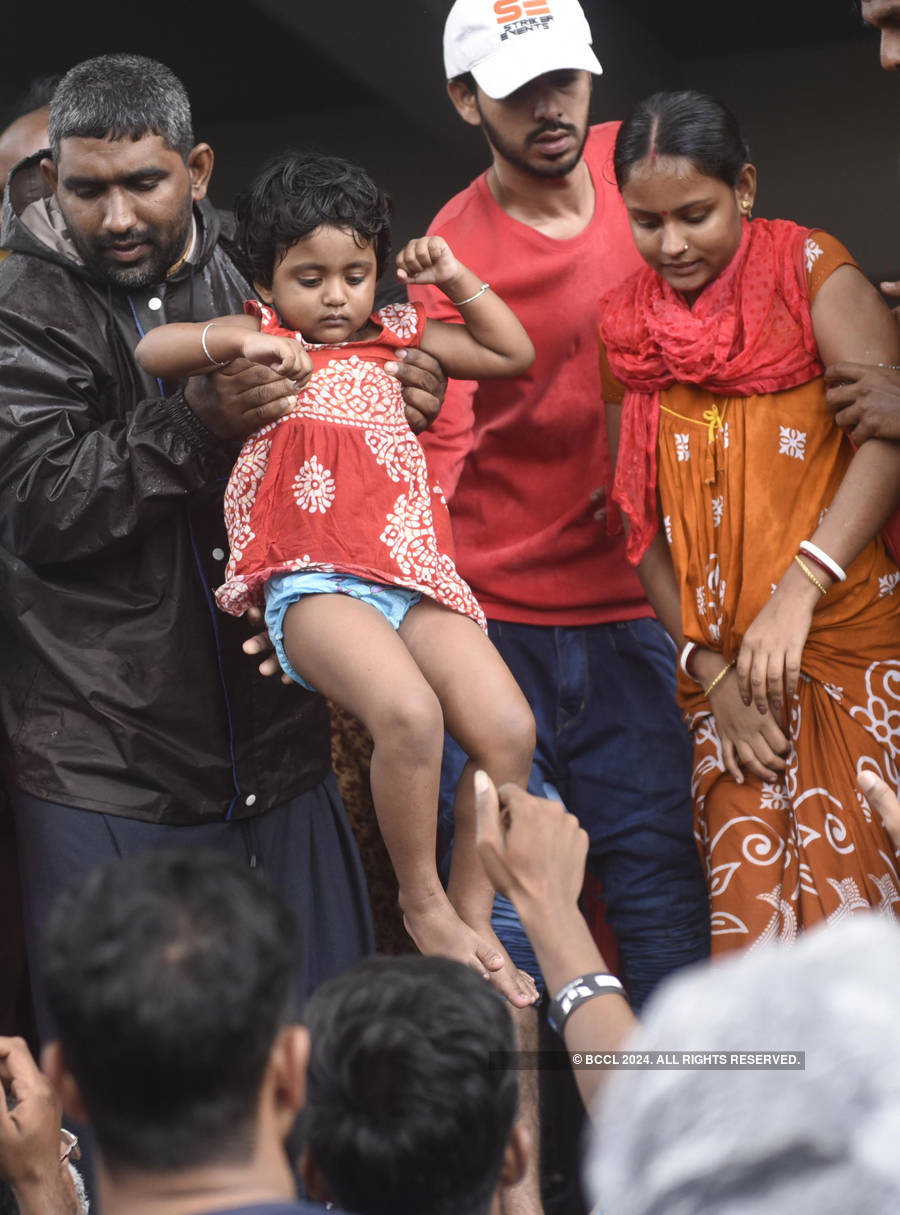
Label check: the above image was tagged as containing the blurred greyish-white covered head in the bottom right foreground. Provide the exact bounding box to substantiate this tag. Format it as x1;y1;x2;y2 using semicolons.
588;913;900;1215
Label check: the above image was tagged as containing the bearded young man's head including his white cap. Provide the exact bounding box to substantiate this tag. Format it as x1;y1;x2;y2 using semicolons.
443;0;602;179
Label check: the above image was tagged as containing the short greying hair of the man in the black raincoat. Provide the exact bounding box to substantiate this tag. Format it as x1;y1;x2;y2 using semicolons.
47;55;194;160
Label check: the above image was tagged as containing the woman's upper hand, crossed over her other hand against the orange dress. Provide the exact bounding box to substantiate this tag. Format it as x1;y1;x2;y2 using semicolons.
737;563;816;718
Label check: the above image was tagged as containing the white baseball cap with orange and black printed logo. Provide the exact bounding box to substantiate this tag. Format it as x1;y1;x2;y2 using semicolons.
443;0;602;97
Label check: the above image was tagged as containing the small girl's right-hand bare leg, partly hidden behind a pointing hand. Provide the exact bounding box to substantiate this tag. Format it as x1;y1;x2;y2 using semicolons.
400;599;537;1006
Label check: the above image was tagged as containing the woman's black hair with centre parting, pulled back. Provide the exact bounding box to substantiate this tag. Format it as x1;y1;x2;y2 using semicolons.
612;90;751;190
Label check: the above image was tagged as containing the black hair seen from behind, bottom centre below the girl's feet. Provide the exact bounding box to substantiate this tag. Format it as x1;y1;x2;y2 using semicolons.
304;956;519;1215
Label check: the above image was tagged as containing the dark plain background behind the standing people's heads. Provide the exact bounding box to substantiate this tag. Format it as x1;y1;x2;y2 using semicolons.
0;0;900;278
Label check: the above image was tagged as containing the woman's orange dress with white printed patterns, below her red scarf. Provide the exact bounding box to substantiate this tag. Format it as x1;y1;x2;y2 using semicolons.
600;233;900;953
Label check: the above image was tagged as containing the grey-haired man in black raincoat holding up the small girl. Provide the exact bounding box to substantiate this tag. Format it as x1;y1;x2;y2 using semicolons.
0;55;436;1035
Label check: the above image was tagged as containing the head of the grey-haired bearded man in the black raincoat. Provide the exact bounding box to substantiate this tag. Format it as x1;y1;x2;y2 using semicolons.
41;55;213;288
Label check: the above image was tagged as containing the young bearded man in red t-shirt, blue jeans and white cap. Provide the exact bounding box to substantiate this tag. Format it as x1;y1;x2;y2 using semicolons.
411;0;709;1035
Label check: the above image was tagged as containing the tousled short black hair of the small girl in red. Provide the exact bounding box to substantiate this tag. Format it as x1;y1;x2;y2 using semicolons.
234;152;391;287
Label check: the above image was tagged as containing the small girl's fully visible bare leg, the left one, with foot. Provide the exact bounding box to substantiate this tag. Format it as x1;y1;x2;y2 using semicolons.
283;594;503;974
